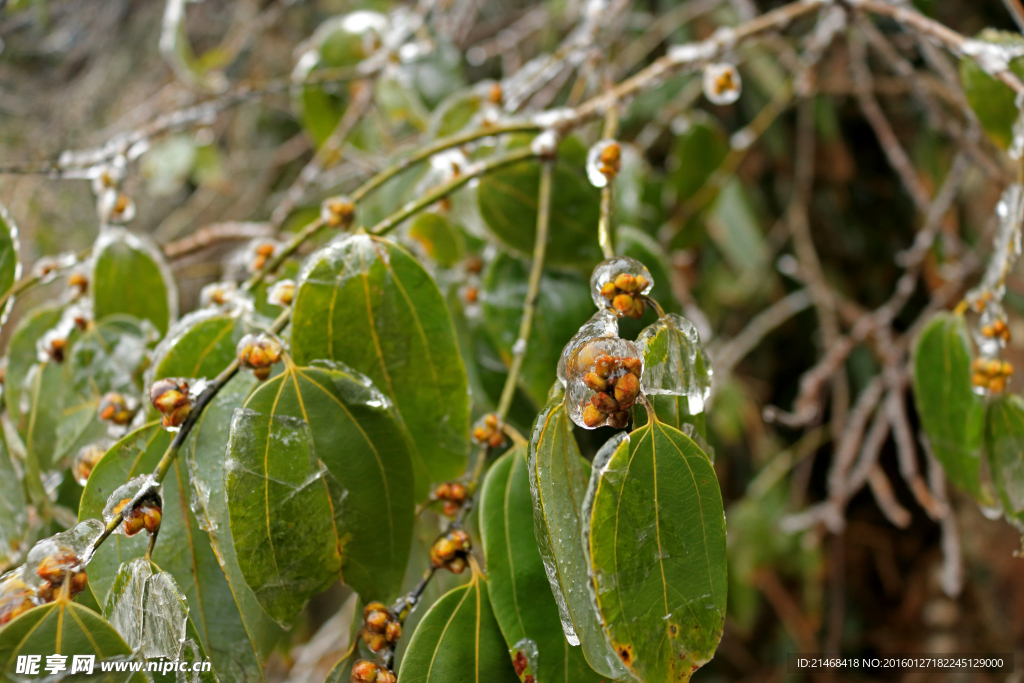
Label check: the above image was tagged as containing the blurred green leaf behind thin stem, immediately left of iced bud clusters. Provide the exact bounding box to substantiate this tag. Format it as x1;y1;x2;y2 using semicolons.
481;254;594;405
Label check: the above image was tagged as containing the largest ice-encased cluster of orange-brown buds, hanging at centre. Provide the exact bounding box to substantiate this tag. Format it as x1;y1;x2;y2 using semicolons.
565;337;643;429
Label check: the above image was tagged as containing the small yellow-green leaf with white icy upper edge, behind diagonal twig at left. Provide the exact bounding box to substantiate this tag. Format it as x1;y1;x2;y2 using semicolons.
153;308;245;380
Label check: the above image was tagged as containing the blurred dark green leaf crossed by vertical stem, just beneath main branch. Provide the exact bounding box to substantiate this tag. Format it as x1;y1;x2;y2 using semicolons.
476;137;601;268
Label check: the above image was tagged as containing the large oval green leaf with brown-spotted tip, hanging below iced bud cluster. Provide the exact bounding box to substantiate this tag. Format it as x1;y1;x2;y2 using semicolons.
585;422;727;683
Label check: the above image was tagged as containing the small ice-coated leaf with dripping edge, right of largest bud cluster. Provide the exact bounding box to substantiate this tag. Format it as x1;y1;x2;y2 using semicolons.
634;313;712;435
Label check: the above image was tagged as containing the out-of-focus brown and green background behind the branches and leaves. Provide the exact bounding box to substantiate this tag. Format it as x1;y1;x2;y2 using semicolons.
0;0;1024;681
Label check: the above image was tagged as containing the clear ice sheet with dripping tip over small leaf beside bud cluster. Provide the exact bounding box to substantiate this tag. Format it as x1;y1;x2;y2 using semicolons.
637;313;712;415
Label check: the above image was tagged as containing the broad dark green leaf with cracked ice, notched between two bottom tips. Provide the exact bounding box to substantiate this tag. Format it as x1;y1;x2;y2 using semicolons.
225;362;414;625
